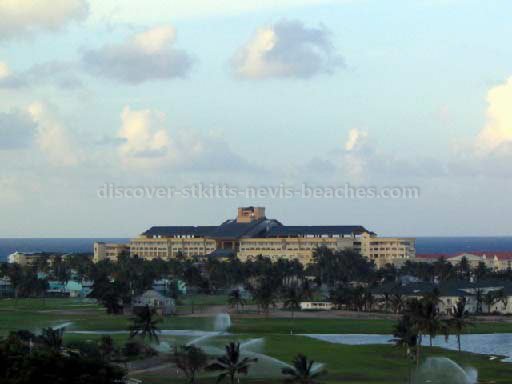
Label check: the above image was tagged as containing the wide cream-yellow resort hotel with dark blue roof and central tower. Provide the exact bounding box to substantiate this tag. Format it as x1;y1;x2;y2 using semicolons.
94;207;415;267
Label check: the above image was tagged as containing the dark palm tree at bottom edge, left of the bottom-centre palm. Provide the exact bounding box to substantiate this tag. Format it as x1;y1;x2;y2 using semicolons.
206;343;258;384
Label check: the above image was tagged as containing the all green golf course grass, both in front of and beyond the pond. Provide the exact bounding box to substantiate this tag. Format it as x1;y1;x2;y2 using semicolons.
0;297;512;384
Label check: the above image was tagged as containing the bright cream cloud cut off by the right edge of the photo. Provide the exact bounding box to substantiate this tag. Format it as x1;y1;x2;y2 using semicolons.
477;77;512;153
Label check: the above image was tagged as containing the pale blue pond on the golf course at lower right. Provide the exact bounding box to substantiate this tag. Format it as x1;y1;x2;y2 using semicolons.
302;333;512;362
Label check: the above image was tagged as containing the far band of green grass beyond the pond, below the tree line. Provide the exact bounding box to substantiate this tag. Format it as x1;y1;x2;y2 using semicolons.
0;295;512;335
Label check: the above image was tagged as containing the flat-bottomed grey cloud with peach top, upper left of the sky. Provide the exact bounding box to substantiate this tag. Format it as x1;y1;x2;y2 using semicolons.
82;26;194;84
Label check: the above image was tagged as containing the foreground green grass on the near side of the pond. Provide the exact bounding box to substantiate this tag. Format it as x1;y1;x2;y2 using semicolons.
134;335;512;384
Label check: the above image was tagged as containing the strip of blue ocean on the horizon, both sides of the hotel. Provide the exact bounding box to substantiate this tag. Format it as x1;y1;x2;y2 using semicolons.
0;237;512;261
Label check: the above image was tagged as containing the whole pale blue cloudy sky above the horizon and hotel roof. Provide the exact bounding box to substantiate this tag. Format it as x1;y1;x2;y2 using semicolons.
0;0;512;237
